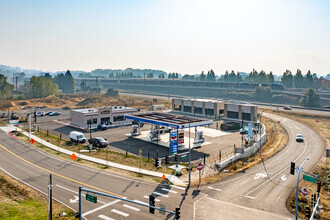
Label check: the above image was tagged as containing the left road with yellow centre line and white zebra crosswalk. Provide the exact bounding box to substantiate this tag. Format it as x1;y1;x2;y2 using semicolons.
0;131;193;219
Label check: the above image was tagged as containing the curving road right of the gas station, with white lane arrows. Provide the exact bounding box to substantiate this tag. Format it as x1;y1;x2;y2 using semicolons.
194;113;324;219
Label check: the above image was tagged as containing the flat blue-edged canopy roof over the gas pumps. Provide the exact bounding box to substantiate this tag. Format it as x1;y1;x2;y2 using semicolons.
125;112;213;129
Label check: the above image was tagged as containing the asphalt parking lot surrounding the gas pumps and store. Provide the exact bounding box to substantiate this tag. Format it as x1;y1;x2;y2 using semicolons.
17;109;242;162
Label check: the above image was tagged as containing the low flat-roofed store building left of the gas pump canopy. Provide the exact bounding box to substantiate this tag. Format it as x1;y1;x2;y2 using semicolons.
70;106;138;129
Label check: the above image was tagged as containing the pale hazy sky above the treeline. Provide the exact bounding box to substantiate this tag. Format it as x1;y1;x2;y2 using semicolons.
0;0;330;75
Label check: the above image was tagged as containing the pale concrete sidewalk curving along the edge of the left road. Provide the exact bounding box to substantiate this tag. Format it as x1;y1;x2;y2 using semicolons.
0;125;186;187
